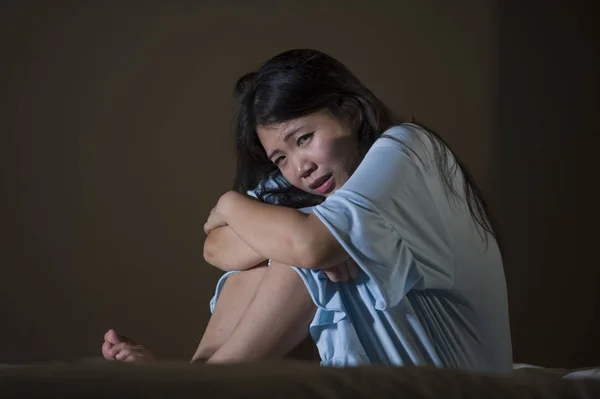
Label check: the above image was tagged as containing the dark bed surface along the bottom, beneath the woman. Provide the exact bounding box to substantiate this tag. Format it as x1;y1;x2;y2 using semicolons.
0;360;600;399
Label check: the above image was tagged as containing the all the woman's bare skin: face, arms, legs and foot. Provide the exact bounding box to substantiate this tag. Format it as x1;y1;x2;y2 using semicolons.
102;111;360;363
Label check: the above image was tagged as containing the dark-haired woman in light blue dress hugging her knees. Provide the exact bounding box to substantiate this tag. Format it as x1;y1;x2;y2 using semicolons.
102;50;512;372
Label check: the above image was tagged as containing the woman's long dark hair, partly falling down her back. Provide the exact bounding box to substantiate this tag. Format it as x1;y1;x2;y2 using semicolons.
234;49;498;244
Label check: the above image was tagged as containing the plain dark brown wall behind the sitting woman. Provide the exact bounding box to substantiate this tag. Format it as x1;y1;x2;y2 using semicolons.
0;0;600;367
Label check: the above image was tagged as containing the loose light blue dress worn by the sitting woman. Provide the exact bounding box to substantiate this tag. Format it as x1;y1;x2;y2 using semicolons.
211;124;512;372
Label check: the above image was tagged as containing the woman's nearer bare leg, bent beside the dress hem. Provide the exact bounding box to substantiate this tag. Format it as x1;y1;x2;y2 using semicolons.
208;264;316;363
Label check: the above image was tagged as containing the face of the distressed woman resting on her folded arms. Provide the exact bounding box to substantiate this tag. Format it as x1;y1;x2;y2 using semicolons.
257;111;360;196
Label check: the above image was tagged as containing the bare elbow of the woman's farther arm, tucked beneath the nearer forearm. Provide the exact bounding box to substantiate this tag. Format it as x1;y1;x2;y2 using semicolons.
204;226;266;271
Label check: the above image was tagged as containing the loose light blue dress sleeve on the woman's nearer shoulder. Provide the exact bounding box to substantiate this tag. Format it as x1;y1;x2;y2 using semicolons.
314;127;454;309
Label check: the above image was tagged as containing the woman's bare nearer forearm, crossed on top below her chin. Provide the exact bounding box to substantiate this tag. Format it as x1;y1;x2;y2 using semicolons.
216;191;348;269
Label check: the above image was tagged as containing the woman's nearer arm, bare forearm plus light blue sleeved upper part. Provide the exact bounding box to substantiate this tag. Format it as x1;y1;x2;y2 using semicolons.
216;127;424;269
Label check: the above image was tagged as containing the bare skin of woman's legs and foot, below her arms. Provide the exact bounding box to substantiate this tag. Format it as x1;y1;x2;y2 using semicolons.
102;264;319;364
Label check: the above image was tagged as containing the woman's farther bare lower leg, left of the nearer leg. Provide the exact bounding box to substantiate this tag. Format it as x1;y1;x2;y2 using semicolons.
192;262;267;363
